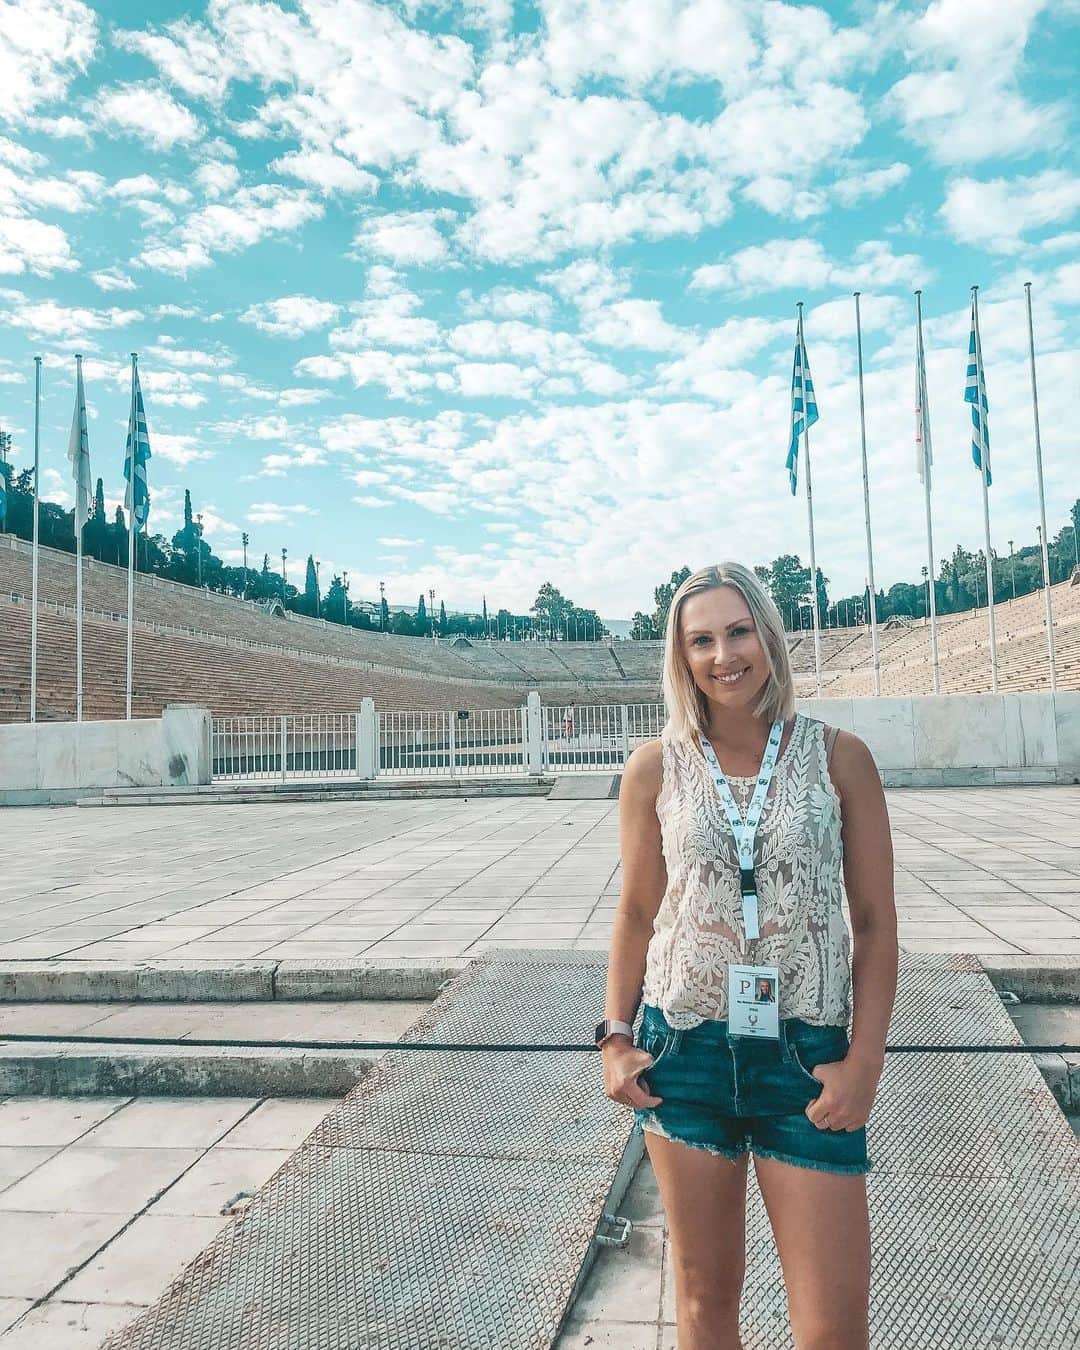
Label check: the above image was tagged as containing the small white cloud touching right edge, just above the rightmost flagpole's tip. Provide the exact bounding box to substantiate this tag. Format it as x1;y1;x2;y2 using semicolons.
941;169;1080;252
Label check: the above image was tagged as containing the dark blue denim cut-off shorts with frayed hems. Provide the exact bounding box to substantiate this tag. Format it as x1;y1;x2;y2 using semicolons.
635;1003;873;1173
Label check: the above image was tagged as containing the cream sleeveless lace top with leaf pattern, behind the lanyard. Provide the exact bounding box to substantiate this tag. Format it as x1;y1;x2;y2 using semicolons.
641;713;851;1029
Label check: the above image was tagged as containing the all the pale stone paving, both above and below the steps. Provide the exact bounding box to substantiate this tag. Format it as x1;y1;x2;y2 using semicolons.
0;787;1080;1350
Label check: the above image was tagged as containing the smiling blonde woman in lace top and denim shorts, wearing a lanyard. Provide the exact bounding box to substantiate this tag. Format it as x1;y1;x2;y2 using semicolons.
597;563;898;1350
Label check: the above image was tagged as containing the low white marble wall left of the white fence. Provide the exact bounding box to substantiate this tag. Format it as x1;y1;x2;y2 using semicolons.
0;705;211;791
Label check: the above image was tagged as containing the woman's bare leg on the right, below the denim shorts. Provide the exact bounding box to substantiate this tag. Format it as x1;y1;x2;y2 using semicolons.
753;1156;871;1350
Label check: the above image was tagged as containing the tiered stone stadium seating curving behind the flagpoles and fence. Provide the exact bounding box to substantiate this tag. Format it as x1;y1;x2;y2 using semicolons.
0;535;1080;721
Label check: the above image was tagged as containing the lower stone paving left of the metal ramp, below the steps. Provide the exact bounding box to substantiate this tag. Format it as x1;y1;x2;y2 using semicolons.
0;1098;336;1350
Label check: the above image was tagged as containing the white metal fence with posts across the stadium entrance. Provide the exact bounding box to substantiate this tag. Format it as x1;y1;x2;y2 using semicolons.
211;695;666;782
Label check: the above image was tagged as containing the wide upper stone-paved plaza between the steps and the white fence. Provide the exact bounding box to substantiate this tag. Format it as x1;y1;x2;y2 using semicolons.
0;787;1080;963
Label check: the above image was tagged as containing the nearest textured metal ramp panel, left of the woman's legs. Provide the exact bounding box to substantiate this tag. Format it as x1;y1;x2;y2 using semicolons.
108;1146;612;1350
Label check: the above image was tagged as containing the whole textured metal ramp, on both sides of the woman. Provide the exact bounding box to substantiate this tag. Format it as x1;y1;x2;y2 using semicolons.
99;950;1080;1350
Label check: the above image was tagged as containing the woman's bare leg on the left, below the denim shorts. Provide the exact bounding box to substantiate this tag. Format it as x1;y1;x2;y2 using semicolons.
645;1130;748;1350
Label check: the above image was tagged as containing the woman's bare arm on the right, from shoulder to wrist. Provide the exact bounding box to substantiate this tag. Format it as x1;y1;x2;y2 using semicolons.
829;732;899;1072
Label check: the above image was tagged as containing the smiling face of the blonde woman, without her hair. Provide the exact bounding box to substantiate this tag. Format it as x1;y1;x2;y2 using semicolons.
679;586;770;722
